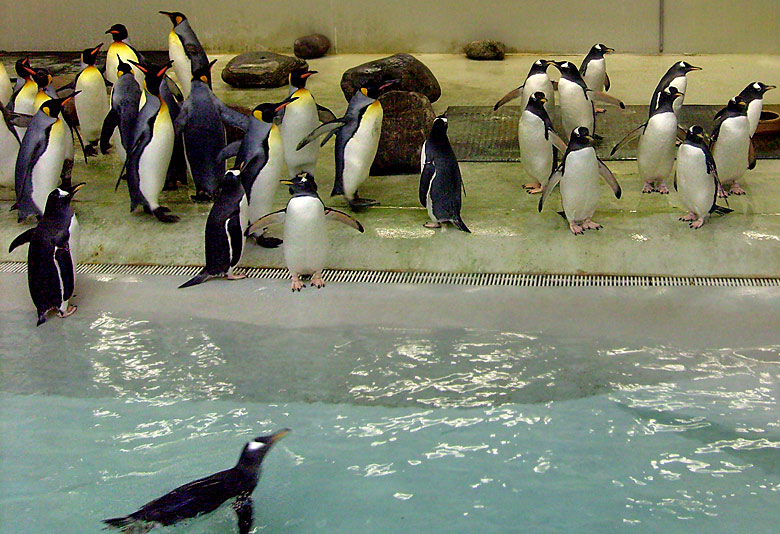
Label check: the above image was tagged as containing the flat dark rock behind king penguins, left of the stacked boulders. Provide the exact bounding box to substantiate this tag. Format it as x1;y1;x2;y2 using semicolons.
222;52;308;87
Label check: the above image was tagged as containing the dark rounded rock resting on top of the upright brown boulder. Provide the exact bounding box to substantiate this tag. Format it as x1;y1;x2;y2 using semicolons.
341;54;441;102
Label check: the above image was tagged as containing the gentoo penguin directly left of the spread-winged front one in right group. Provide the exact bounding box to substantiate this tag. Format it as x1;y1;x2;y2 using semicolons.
517;91;566;194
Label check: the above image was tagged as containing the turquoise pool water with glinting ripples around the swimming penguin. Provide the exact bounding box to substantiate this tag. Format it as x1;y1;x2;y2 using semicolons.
0;310;780;534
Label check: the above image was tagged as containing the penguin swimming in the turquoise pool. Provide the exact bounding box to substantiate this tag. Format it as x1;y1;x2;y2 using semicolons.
103;428;290;534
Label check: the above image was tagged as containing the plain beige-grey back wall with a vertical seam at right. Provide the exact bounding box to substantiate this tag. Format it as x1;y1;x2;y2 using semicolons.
0;0;780;53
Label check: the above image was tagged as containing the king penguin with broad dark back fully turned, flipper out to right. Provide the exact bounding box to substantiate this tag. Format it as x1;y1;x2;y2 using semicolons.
174;60;248;201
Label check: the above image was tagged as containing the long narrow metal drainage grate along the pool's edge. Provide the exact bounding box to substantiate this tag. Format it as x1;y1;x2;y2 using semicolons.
0;262;780;287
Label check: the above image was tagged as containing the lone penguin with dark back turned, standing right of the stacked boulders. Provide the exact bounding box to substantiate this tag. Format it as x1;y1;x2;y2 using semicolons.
420;116;471;233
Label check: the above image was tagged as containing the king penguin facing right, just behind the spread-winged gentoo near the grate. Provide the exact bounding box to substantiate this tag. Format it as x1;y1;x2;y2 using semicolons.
218;96;298;248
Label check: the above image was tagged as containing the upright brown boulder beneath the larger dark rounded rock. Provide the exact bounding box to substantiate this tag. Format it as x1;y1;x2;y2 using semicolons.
371;91;436;175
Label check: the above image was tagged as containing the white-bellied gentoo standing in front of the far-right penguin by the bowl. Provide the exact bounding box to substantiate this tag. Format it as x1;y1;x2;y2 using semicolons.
711;96;756;197
